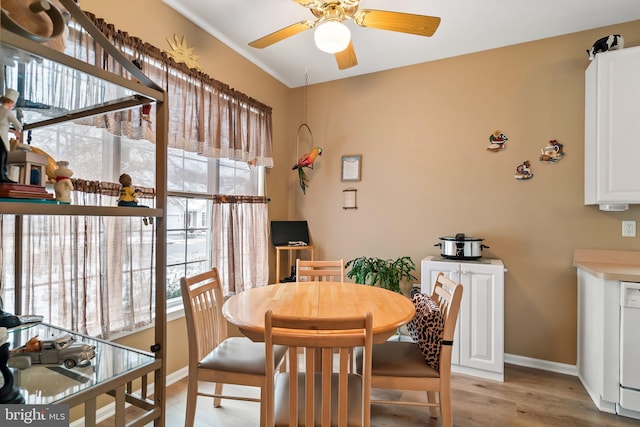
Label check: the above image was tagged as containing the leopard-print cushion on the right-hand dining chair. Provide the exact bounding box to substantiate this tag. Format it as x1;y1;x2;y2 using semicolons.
407;292;444;371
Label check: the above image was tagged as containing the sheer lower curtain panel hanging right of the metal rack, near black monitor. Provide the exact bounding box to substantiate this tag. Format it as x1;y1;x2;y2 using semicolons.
211;196;269;295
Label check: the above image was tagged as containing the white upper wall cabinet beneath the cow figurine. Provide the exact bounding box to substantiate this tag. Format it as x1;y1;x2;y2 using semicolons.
584;47;640;210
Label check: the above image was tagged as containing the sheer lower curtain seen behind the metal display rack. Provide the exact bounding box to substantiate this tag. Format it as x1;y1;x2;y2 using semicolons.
8;186;155;338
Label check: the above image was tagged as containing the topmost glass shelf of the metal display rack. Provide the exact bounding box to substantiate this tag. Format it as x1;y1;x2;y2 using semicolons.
0;29;163;130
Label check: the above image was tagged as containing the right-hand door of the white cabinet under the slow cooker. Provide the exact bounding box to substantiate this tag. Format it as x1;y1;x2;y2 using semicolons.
459;263;504;373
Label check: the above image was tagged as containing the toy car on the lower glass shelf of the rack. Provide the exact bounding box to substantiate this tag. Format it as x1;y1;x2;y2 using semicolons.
7;335;96;369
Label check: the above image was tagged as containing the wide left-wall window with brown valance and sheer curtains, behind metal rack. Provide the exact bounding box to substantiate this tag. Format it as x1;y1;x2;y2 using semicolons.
0;16;273;338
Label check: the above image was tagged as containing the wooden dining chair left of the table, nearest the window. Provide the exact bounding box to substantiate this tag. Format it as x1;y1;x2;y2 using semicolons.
180;268;287;427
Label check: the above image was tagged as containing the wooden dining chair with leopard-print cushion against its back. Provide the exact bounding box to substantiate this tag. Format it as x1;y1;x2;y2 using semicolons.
356;273;462;427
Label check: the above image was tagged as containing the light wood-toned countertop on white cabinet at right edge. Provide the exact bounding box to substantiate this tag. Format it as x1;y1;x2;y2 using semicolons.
573;249;640;282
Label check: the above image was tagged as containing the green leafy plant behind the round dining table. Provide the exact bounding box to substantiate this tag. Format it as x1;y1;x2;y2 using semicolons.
345;256;417;294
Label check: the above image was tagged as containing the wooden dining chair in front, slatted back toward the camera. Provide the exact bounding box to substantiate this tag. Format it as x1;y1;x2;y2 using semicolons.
265;310;373;427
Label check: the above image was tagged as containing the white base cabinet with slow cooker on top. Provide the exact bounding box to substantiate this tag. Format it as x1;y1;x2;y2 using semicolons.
421;256;505;381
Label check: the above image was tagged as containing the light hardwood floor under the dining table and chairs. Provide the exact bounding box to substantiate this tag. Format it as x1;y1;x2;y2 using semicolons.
100;365;640;427
